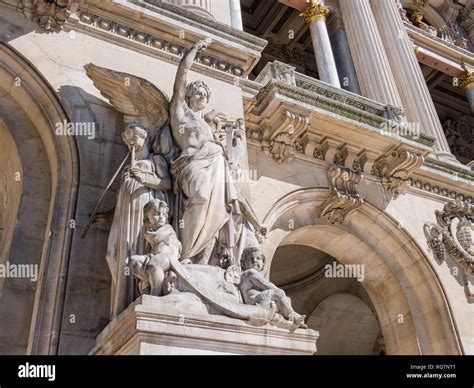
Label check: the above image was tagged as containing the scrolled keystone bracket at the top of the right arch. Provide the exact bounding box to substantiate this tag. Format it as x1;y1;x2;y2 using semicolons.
320;165;364;224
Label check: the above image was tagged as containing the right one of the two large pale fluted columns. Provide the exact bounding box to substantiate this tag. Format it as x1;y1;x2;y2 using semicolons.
370;0;455;156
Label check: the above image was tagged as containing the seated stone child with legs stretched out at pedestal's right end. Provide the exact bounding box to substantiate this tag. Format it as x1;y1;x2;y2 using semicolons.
240;247;307;328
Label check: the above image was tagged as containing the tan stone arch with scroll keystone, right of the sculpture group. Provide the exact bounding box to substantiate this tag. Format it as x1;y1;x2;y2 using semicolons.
262;188;462;354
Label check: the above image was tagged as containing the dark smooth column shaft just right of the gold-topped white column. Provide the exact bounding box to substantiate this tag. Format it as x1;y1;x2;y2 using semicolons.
328;8;362;94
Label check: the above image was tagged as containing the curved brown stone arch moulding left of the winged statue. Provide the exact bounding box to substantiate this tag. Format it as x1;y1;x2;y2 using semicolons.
0;42;79;354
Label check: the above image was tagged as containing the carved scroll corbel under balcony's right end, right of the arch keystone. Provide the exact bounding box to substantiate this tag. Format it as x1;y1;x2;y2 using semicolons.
371;145;424;198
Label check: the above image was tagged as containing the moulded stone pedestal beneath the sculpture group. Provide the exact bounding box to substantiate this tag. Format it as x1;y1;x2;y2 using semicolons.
90;295;319;355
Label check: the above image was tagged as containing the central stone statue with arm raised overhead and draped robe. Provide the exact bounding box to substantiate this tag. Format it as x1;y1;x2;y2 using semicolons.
170;39;258;266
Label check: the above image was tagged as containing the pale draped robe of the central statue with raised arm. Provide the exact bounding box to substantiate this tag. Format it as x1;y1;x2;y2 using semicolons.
171;135;258;264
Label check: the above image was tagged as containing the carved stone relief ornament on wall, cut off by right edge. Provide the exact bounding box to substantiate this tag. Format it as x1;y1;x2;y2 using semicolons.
424;201;474;300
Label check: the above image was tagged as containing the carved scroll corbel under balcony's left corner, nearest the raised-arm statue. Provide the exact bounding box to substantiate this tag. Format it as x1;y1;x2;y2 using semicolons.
262;110;309;163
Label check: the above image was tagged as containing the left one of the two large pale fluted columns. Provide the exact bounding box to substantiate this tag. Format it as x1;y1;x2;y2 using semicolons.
339;0;402;107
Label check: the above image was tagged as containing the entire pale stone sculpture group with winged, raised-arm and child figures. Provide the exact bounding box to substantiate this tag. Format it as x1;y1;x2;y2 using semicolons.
85;39;306;327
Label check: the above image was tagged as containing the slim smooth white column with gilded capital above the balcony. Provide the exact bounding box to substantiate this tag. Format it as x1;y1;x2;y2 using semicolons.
300;0;341;88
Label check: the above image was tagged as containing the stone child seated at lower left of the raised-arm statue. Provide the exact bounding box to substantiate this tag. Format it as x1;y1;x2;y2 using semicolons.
127;199;181;296
